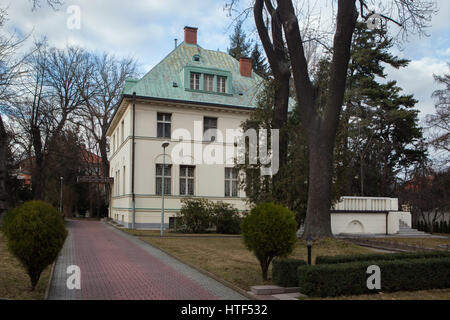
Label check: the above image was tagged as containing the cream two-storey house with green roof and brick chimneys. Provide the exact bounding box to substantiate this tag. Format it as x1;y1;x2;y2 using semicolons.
107;27;262;229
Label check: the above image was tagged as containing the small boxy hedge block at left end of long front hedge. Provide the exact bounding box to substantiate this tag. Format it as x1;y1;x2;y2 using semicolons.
272;258;306;287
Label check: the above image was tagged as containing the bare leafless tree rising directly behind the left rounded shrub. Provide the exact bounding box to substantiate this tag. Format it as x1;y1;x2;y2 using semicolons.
11;43;86;199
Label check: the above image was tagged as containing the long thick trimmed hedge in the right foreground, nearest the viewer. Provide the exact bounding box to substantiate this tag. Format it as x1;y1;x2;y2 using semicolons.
298;257;450;297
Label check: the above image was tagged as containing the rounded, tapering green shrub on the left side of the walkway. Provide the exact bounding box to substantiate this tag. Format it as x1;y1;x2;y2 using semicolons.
2;201;67;290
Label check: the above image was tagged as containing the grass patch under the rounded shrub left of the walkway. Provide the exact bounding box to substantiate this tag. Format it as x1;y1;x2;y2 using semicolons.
0;232;51;300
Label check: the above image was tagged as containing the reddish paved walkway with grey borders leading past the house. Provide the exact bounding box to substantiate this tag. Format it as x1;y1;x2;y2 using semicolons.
48;220;246;300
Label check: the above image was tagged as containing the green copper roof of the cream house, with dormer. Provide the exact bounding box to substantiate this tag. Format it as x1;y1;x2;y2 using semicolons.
123;42;263;108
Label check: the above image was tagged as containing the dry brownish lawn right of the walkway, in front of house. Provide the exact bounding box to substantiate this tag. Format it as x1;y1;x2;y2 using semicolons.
141;236;373;291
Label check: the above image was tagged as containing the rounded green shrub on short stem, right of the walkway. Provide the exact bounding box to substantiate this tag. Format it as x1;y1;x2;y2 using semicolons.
241;202;297;280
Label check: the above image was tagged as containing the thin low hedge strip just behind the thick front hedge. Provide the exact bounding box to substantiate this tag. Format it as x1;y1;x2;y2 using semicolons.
316;251;450;264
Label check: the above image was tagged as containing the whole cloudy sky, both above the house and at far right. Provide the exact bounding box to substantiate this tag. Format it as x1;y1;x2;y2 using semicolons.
0;0;450;124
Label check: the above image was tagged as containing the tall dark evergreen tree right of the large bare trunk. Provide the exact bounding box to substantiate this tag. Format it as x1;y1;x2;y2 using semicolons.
337;24;426;196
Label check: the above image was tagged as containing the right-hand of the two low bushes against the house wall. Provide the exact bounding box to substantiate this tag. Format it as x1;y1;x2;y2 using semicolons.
212;201;242;234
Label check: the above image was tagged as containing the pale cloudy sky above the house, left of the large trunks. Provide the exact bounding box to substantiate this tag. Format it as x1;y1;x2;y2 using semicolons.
0;0;230;71
